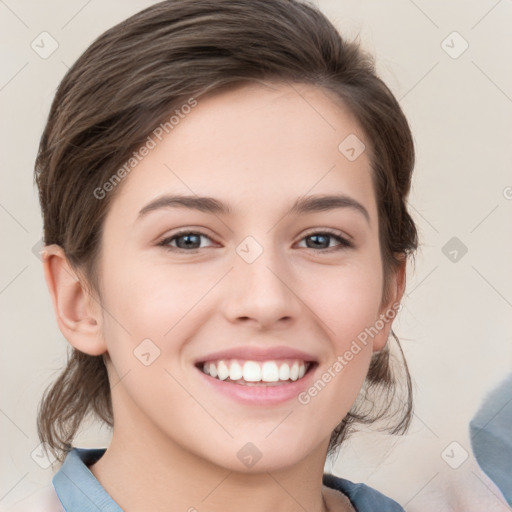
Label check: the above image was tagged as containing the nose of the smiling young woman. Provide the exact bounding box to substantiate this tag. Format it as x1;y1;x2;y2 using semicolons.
224;244;301;330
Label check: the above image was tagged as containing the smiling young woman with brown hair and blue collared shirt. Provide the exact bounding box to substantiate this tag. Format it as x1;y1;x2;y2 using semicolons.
25;0;417;512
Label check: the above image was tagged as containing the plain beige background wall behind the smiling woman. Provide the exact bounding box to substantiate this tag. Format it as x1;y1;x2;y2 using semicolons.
0;0;512;511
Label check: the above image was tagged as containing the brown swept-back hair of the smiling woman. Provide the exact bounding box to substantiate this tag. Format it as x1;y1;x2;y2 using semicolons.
35;0;418;460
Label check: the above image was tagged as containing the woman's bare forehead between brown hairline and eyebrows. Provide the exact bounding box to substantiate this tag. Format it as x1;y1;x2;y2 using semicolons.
107;83;376;226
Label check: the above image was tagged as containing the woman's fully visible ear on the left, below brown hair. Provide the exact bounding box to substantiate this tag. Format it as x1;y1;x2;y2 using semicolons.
42;244;107;356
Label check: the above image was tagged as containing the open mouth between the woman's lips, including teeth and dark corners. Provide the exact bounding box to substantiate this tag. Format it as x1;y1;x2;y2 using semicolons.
196;359;318;386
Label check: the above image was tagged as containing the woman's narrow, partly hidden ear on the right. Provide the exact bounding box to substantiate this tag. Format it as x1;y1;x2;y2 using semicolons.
373;254;407;352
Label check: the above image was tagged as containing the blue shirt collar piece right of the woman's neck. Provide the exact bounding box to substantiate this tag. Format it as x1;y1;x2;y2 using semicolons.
323;473;405;512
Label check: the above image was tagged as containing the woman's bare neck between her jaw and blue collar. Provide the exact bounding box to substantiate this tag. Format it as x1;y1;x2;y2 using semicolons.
89;418;342;512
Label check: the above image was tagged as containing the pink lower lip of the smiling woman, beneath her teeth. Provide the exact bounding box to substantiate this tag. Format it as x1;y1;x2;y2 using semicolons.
196;365;318;405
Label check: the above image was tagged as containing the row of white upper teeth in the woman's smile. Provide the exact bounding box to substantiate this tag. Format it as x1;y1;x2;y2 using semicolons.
203;359;309;382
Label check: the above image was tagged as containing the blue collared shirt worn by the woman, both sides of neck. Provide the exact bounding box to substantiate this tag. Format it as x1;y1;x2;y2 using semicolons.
7;448;405;512
